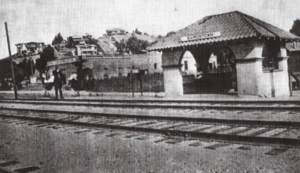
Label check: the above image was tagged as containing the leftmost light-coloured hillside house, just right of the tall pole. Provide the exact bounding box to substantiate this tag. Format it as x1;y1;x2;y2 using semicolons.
16;42;45;56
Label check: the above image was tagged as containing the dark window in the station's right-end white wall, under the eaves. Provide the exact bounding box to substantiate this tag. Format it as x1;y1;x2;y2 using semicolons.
262;40;280;70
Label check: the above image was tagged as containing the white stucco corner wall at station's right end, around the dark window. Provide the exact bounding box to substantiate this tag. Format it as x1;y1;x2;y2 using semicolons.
236;39;289;97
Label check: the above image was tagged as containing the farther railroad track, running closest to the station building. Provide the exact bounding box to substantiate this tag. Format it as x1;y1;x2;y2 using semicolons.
0;99;300;111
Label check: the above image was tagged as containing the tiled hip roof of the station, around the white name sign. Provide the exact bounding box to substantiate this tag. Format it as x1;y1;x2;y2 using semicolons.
148;11;300;50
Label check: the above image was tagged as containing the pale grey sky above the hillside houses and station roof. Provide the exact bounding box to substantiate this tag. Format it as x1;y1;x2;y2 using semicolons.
0;0;300;59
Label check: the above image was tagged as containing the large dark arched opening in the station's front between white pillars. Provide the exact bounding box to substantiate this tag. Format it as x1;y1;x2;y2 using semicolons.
181;46;237;94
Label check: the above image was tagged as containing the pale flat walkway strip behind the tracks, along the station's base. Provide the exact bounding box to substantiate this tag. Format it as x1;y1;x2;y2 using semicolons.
0;90;300;101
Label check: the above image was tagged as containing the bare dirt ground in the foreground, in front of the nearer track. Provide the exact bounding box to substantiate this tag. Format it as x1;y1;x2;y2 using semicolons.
0;119;300;173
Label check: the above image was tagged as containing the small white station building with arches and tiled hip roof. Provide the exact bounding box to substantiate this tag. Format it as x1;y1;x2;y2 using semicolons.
148;11;300;97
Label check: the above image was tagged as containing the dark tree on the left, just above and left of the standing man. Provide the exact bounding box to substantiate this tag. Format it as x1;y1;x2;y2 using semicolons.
36;45;55;73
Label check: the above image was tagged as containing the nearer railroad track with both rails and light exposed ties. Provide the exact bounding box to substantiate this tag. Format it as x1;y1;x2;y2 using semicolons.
0;108;300;148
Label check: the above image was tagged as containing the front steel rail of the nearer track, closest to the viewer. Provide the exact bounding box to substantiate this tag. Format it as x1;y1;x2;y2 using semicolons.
0;114;300;147
